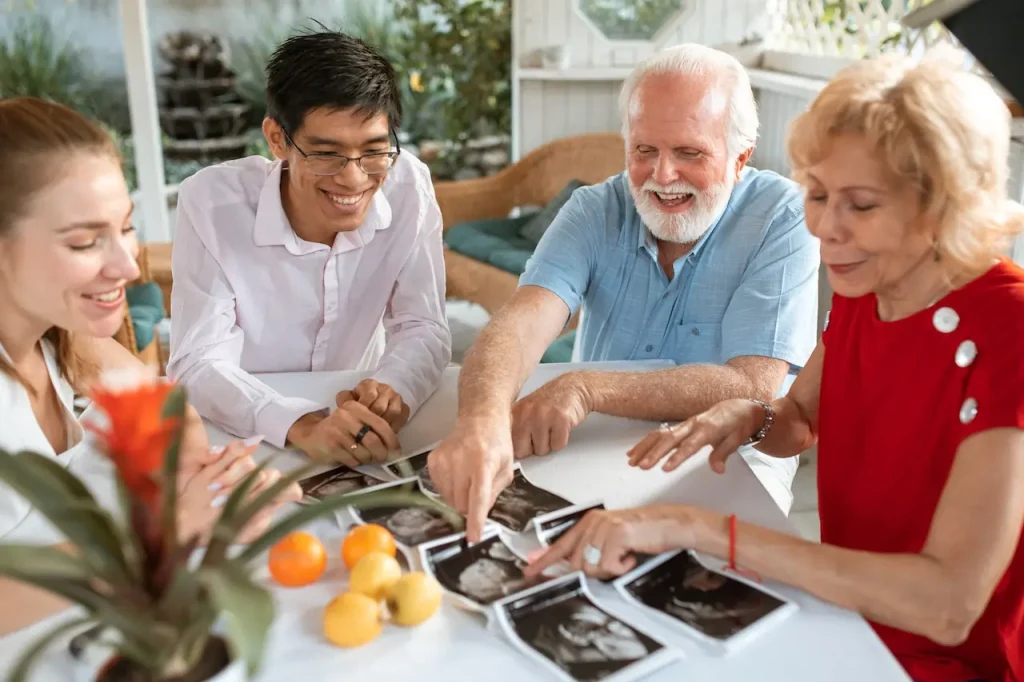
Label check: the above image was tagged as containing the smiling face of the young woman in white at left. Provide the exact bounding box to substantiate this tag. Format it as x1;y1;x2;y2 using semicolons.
0;153;138;346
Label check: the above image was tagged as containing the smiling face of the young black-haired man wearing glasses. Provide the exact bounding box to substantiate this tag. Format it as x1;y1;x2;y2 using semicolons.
263;109;391;245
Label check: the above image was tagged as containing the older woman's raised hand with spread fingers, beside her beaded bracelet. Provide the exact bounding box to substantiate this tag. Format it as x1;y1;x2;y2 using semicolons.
627;398;765;473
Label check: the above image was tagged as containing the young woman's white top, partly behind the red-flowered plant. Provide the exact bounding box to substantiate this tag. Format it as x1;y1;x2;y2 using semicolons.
0;340;95;543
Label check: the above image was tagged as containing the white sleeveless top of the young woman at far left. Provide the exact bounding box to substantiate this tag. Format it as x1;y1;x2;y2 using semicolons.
0;340;115;545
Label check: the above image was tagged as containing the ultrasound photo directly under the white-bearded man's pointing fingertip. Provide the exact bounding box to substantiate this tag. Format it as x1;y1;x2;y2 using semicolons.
421;535;544;606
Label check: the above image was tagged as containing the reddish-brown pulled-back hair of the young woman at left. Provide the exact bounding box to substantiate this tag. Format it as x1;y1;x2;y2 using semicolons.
0;97;120;385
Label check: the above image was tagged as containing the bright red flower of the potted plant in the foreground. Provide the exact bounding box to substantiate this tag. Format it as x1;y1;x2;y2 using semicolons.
89;381;179;509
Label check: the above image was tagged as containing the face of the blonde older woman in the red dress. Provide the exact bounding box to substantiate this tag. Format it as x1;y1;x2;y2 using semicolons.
805;134;936;297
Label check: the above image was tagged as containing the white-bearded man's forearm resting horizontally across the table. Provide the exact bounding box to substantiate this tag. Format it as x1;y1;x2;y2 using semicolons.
573;365;772;421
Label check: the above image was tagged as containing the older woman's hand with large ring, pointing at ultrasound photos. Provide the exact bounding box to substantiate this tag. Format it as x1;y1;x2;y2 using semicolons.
524;505;696;579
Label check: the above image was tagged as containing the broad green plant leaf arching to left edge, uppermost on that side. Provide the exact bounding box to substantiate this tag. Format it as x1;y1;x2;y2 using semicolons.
0;450;130;583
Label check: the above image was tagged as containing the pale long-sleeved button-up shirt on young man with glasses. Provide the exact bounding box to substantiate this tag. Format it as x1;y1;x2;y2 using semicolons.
167;154;452;447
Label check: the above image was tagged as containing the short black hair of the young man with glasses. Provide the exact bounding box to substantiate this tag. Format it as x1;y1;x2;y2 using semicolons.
266;30;401;135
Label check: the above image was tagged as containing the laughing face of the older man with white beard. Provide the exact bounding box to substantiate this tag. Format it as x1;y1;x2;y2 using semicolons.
627;74;750;244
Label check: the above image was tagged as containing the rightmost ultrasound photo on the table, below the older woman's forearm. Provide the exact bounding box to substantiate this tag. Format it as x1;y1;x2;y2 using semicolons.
623;552;785;641
